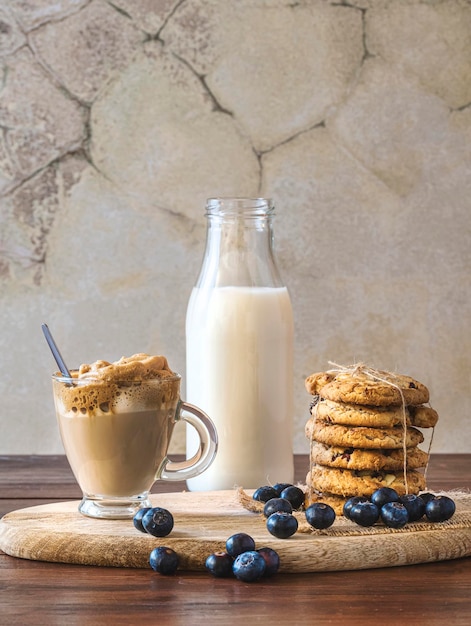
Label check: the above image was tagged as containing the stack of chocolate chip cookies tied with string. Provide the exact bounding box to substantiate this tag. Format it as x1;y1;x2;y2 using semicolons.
305;365;438;514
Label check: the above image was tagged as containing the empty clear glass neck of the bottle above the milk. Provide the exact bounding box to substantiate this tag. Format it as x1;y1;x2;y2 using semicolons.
197;198;283;287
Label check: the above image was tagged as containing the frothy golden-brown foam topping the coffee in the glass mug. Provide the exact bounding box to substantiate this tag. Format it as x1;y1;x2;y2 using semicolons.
56;353;180;416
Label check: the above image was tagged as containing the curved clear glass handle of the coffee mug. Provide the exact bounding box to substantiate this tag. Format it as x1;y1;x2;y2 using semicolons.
157;401;218;480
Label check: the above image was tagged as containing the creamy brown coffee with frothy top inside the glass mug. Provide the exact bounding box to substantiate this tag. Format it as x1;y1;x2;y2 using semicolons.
54;354;180;498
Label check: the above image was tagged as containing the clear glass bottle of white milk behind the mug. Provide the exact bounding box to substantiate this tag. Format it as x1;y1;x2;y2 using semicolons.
186;198;293;491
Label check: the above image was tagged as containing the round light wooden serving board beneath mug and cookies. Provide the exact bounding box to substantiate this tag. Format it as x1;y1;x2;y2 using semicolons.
0;491;471;573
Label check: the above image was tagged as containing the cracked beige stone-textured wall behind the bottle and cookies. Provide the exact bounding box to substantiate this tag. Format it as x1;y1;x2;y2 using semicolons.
0;0;471;453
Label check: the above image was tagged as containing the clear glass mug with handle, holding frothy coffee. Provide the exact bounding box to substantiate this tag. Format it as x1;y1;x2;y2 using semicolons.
52;373;218;519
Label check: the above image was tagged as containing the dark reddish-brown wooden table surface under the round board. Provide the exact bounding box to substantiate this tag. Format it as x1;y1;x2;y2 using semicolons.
0;454;471;626
